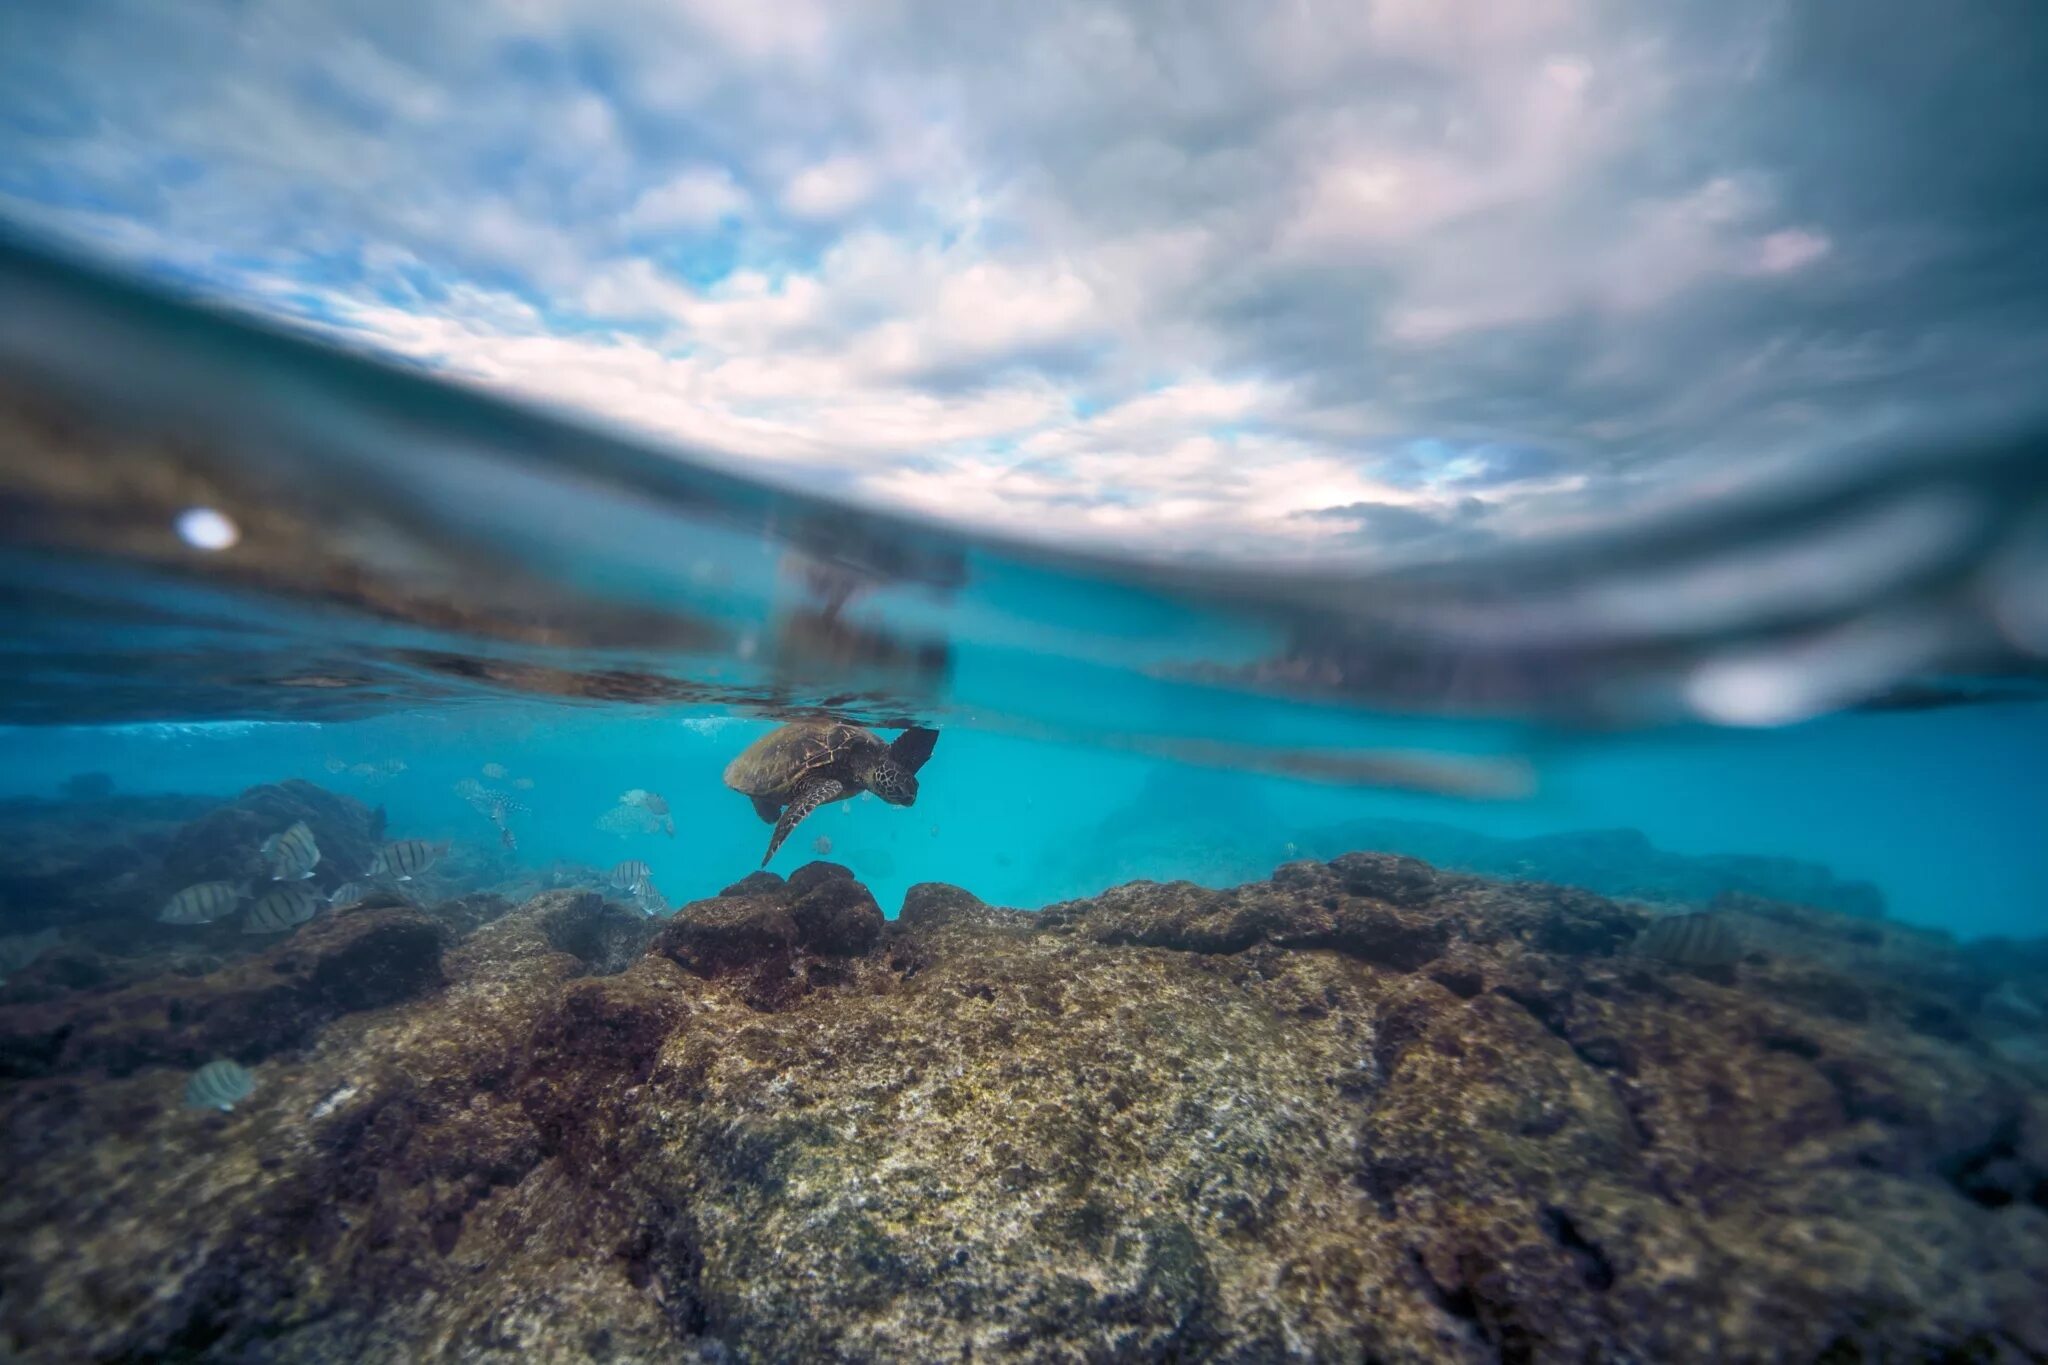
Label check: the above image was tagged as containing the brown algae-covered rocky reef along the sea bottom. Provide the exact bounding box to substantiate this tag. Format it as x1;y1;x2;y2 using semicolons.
0;782;2048;1363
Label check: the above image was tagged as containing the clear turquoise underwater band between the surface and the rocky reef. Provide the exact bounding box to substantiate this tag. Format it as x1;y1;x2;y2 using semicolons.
0;704;2048;935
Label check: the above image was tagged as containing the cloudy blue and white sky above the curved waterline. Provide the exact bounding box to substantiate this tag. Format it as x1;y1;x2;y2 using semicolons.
0;0;2048;557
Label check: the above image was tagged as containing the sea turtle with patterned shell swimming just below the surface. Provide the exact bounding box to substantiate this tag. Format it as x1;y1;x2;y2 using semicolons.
725;720;938;868
